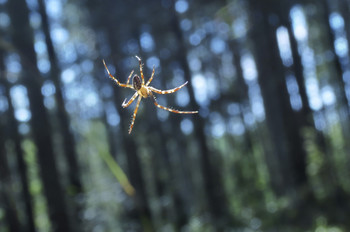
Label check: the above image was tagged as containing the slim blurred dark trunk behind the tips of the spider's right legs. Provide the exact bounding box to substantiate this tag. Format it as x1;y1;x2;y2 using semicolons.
170;0;232;227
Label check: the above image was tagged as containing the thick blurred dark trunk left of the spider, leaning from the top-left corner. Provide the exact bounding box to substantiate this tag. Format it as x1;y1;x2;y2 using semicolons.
8;0;71;231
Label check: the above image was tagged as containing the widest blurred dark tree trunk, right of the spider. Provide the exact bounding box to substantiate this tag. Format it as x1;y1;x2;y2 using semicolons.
250;1;307;194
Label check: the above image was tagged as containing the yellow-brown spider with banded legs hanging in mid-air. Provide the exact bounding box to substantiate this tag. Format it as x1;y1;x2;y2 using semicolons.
102;56;198;134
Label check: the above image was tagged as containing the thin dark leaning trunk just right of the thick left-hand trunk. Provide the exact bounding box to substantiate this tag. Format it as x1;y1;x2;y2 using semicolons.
38;0;83;227
